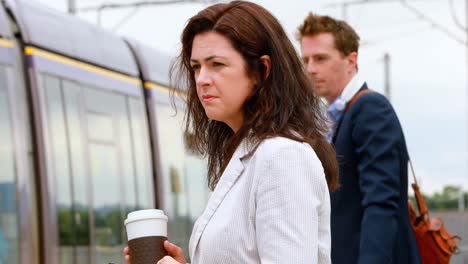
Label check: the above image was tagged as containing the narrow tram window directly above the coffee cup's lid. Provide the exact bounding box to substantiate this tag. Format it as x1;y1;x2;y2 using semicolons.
129;98;154;209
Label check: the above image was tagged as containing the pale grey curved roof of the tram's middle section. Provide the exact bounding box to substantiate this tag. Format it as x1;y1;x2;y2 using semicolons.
6;0;138;76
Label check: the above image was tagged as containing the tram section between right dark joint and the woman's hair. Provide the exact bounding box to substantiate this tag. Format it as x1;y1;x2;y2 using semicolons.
128;40;209;256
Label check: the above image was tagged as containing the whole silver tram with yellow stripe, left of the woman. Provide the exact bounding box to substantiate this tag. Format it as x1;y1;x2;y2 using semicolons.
0;0;209;264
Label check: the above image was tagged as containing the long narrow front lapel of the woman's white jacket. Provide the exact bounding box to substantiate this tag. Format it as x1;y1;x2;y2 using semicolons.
190;140;248;256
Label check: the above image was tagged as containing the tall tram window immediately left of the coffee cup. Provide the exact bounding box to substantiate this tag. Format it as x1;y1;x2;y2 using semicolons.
85;89;124;263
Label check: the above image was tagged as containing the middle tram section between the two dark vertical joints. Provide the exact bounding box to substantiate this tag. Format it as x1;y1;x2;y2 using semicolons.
6;0;155;264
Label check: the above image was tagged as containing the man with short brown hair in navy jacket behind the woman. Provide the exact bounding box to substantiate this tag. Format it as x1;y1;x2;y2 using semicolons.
298;13;420;264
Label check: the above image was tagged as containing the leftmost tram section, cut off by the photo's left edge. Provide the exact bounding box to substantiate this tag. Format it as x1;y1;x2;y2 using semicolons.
0;5;39;264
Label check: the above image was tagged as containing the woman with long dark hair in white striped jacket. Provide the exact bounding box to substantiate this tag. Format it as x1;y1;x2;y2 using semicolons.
125;1;337;264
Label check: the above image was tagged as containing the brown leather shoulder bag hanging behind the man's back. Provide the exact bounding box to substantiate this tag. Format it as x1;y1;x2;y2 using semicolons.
408;160;460;264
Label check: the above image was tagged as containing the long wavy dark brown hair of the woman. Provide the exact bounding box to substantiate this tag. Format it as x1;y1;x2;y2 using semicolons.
171;1;338;190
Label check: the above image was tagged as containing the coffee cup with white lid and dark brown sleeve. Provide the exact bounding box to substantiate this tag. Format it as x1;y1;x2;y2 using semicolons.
124;209;167;264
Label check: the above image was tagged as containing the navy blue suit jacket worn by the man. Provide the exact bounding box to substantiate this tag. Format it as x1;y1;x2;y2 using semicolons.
331;84;420;264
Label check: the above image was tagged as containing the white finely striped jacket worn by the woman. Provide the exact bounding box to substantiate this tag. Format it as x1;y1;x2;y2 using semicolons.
189;137;331;264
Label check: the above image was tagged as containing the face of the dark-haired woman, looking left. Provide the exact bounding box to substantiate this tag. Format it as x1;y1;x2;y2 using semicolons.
190;31;254;131
